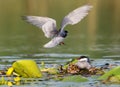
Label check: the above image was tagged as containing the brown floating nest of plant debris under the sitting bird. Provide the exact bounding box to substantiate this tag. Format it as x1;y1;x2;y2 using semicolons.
59;63;104;76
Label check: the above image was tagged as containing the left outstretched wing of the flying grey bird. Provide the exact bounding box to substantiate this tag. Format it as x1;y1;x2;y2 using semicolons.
23;16;57;38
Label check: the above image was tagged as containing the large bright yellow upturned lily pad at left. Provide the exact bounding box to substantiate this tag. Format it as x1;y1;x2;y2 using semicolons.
12;60;42;78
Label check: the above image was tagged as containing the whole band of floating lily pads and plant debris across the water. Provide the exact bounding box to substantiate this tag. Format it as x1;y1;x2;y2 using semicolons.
0;59;120;87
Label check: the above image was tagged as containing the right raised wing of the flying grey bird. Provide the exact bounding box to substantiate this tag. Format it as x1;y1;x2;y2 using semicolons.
61;5;92;31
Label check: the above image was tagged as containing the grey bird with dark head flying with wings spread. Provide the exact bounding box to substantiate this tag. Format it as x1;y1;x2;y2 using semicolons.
23;5;92;48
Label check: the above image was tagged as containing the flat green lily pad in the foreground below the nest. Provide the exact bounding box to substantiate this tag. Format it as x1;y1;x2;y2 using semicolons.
62;75;88;82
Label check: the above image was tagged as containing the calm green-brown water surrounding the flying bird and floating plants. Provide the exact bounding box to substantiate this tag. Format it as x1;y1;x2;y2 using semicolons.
0;0;120;87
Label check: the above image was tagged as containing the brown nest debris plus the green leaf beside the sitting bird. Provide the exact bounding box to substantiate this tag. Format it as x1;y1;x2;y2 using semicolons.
60;59;104;76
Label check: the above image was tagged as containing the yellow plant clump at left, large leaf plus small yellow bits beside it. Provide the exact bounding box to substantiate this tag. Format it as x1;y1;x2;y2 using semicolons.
0;60;42;87
